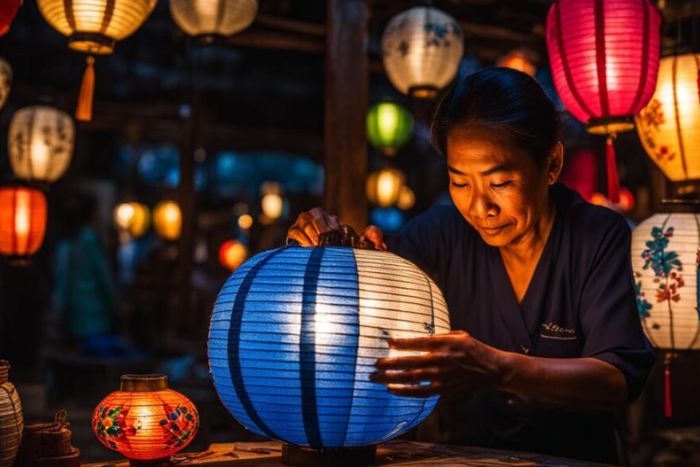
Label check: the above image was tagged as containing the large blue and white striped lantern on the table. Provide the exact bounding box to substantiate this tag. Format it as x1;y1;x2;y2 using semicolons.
209;246;450;449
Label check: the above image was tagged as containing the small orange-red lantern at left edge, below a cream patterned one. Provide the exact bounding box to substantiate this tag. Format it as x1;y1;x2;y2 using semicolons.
0;185;46;258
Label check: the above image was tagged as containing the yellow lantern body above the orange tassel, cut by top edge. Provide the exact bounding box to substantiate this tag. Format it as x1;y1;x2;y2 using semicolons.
37;0;156;54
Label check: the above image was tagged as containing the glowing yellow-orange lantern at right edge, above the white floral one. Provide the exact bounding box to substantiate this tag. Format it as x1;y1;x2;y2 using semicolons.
635;54;700;182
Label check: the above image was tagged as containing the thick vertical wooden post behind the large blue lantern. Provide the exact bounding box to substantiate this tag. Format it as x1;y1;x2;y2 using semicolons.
324;0;369;231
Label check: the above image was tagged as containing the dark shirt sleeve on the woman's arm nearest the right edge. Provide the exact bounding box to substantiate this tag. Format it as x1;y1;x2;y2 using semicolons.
580;217;655;401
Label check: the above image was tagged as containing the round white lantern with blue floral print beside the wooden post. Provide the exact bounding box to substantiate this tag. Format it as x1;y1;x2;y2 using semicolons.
382;6;464;97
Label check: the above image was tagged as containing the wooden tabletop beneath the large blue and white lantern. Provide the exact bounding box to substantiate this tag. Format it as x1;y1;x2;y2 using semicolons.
82;440;600;467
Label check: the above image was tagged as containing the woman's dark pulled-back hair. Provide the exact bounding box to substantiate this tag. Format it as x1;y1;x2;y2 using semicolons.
430;67;560;167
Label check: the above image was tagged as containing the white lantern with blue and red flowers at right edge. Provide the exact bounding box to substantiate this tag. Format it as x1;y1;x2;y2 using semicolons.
632;214;700;350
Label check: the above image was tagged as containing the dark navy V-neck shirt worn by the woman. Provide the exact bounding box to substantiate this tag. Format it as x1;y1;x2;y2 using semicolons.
389;184;654;462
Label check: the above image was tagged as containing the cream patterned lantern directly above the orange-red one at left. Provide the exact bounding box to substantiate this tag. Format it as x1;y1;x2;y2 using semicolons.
7;105;75;182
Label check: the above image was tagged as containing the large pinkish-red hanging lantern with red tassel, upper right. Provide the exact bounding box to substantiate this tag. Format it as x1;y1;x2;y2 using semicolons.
547;0;661;202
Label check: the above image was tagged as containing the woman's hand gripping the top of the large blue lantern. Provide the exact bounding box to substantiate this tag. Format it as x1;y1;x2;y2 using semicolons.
287;208;387;251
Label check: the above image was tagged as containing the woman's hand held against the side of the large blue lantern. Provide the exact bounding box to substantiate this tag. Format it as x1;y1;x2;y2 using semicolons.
370;331;506;397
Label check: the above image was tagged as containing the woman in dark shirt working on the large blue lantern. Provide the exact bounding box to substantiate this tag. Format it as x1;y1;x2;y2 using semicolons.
289;68;653;462
